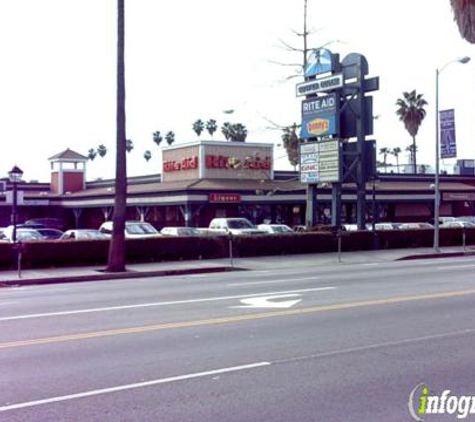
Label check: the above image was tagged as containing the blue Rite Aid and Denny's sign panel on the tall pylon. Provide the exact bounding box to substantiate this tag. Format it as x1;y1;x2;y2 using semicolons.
300;94;338;139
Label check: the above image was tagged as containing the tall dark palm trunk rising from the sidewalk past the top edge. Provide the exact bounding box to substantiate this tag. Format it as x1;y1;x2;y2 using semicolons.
106;0;127;272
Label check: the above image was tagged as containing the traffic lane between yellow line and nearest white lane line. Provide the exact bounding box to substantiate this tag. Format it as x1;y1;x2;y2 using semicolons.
0;290;475;416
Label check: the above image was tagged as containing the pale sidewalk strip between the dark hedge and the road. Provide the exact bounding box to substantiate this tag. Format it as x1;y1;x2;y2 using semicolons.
0;247;475;287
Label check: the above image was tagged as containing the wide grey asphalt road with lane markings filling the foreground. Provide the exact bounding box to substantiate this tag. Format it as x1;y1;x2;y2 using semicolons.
0;257;475;422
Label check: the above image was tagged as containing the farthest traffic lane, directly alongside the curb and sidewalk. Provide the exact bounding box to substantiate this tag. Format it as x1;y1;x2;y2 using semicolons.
0;254;475;311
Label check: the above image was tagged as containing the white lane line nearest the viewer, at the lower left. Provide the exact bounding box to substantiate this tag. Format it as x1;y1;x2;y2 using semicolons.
0;362;272;412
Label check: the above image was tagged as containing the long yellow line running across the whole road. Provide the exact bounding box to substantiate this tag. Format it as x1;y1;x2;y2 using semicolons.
0;289;475;349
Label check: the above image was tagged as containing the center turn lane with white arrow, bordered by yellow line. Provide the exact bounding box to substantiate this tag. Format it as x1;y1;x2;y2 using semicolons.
0;268;475;343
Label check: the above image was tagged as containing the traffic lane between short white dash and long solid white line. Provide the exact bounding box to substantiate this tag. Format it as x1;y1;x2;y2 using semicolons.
0;256;473;318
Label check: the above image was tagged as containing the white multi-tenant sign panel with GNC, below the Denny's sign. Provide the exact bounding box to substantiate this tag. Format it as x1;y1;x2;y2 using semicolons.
300;140;340;183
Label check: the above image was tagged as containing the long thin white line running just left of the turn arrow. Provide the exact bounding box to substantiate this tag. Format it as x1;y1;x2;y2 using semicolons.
0;286;336;321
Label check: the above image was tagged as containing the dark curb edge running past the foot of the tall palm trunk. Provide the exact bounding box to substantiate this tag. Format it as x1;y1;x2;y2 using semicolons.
0;266;245;288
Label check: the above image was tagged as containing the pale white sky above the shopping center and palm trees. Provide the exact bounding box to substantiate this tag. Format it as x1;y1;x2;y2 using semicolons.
0;0;475;182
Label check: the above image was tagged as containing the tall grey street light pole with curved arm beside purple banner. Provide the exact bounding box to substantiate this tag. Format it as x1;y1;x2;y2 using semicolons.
434;56;470;252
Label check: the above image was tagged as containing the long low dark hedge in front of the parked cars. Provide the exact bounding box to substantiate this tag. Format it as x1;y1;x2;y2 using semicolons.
0;228;475;269
